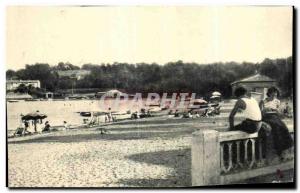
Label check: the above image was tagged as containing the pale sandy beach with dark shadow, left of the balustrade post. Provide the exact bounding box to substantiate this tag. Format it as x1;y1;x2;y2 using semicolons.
8;117;204;187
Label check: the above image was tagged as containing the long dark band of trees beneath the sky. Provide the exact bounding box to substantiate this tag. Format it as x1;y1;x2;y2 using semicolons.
6;57;293;97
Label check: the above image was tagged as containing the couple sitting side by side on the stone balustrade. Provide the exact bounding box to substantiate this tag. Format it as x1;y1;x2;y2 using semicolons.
229;87;294;160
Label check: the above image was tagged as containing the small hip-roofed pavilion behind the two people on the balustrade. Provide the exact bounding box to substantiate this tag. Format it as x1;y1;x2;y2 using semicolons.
231;74;276;99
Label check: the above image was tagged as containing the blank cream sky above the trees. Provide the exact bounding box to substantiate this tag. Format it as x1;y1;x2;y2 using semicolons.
6;6;293;70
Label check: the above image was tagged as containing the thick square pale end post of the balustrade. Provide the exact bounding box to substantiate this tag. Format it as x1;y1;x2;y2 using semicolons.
191;130;221;186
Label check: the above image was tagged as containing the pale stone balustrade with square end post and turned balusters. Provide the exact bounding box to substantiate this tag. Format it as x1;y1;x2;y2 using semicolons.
191;125;294;186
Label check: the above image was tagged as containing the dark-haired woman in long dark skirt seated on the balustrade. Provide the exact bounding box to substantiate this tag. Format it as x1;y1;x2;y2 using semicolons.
260;87;293;159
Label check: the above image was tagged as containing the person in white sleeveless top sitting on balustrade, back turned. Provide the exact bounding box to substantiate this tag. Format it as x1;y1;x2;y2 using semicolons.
229;87;262;133
